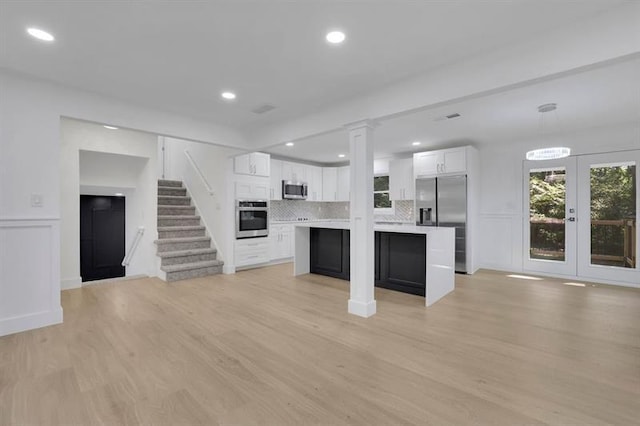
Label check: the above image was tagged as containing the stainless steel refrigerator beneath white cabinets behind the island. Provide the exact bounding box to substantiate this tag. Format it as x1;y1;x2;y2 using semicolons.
414;175;467;273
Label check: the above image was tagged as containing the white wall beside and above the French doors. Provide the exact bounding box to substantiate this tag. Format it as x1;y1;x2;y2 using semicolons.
477;123;640;272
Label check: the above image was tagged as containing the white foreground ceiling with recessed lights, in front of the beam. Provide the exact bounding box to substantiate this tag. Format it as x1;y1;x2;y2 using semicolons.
0;0;624;131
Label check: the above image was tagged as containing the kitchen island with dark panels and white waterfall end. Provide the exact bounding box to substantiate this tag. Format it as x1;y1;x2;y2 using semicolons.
294;221;455;306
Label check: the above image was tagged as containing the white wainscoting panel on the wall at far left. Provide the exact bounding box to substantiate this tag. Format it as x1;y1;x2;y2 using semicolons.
0;218;62;336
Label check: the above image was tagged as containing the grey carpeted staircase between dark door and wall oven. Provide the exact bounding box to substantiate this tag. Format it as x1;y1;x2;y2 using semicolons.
156;179;223;281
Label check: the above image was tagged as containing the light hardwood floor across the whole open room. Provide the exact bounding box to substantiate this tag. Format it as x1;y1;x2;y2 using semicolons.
0;264;640;425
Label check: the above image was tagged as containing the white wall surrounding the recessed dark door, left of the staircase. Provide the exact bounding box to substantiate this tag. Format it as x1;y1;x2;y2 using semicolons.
60;118;157;289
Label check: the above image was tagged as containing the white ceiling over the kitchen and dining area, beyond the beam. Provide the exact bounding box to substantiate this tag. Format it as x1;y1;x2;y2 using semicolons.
268;59;640;163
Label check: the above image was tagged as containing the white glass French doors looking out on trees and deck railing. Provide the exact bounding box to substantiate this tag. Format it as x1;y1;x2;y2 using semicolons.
523;151;640;286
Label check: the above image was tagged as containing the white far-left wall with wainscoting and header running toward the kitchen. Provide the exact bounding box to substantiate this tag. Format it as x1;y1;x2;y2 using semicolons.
0;71;246;335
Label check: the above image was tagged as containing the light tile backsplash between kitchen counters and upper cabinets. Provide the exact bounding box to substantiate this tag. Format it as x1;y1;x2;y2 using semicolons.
271;200;413;222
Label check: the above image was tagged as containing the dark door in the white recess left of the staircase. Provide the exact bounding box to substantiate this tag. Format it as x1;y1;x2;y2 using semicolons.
80;195;125;281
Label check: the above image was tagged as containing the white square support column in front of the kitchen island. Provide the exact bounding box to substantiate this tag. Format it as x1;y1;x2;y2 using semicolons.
346;120;376;318
